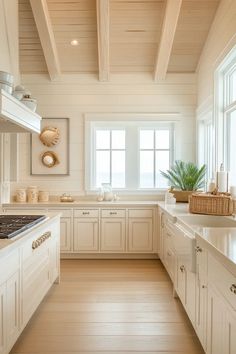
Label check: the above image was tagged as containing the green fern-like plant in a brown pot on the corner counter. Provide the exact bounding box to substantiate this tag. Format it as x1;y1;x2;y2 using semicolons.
160;160;206;202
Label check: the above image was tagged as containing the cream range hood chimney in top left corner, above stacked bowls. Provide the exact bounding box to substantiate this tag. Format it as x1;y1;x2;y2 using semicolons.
0;0;19;84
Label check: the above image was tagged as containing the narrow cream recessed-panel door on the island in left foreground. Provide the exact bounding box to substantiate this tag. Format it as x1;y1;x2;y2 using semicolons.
6;271;20;349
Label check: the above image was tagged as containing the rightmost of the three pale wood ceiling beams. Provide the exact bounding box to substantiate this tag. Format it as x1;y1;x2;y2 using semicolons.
154;0;182;81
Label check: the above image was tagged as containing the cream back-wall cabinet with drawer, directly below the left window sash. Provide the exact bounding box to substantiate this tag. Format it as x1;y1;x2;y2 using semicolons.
100;209;126;253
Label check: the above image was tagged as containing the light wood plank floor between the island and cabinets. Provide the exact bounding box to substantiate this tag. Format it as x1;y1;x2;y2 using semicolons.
11;260;203;354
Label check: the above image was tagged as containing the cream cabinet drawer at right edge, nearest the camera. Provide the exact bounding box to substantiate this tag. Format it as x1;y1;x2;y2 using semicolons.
208;254;236;310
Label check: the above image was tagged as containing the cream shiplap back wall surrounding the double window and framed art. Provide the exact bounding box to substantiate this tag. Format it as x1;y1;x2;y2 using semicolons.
12;74;196;195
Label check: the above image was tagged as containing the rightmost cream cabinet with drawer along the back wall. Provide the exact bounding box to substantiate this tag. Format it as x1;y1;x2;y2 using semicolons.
128;209;153;253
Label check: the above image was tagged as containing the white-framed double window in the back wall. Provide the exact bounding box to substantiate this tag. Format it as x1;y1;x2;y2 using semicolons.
85;121;174;191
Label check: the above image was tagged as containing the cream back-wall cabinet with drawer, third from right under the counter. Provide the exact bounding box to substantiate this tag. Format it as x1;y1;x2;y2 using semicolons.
73;209;99;253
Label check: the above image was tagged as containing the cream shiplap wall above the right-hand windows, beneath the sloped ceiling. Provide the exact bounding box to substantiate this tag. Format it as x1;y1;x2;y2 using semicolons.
198;0;236;112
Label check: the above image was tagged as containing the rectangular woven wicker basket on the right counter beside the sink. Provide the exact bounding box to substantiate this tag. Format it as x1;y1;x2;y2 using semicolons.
189;193;233;215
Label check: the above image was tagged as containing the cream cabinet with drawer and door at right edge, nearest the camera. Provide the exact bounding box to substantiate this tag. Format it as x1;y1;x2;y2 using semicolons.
206;252;236;354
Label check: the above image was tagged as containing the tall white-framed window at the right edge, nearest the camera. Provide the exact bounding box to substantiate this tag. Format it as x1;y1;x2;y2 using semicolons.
215;48;236;185
